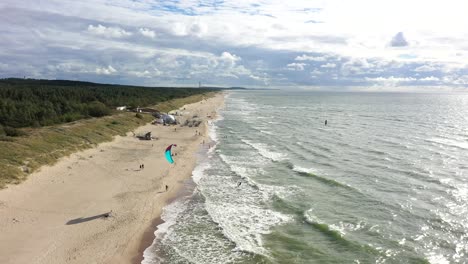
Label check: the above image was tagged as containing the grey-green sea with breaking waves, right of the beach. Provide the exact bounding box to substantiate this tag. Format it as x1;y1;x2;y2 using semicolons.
142;90;468;264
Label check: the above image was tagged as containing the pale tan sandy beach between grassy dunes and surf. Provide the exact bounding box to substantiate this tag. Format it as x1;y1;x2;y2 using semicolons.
0;93;224;264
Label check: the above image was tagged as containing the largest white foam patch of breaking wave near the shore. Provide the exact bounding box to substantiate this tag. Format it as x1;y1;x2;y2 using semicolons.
199;154;293;256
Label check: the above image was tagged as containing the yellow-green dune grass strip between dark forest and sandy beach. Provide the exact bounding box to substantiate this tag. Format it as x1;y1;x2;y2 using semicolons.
0;92;215;188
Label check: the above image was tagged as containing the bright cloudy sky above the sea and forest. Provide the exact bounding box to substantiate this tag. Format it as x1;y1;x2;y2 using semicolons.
0;0;468;91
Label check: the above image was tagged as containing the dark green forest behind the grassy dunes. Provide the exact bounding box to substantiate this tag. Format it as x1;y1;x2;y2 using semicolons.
0;79;213;128
